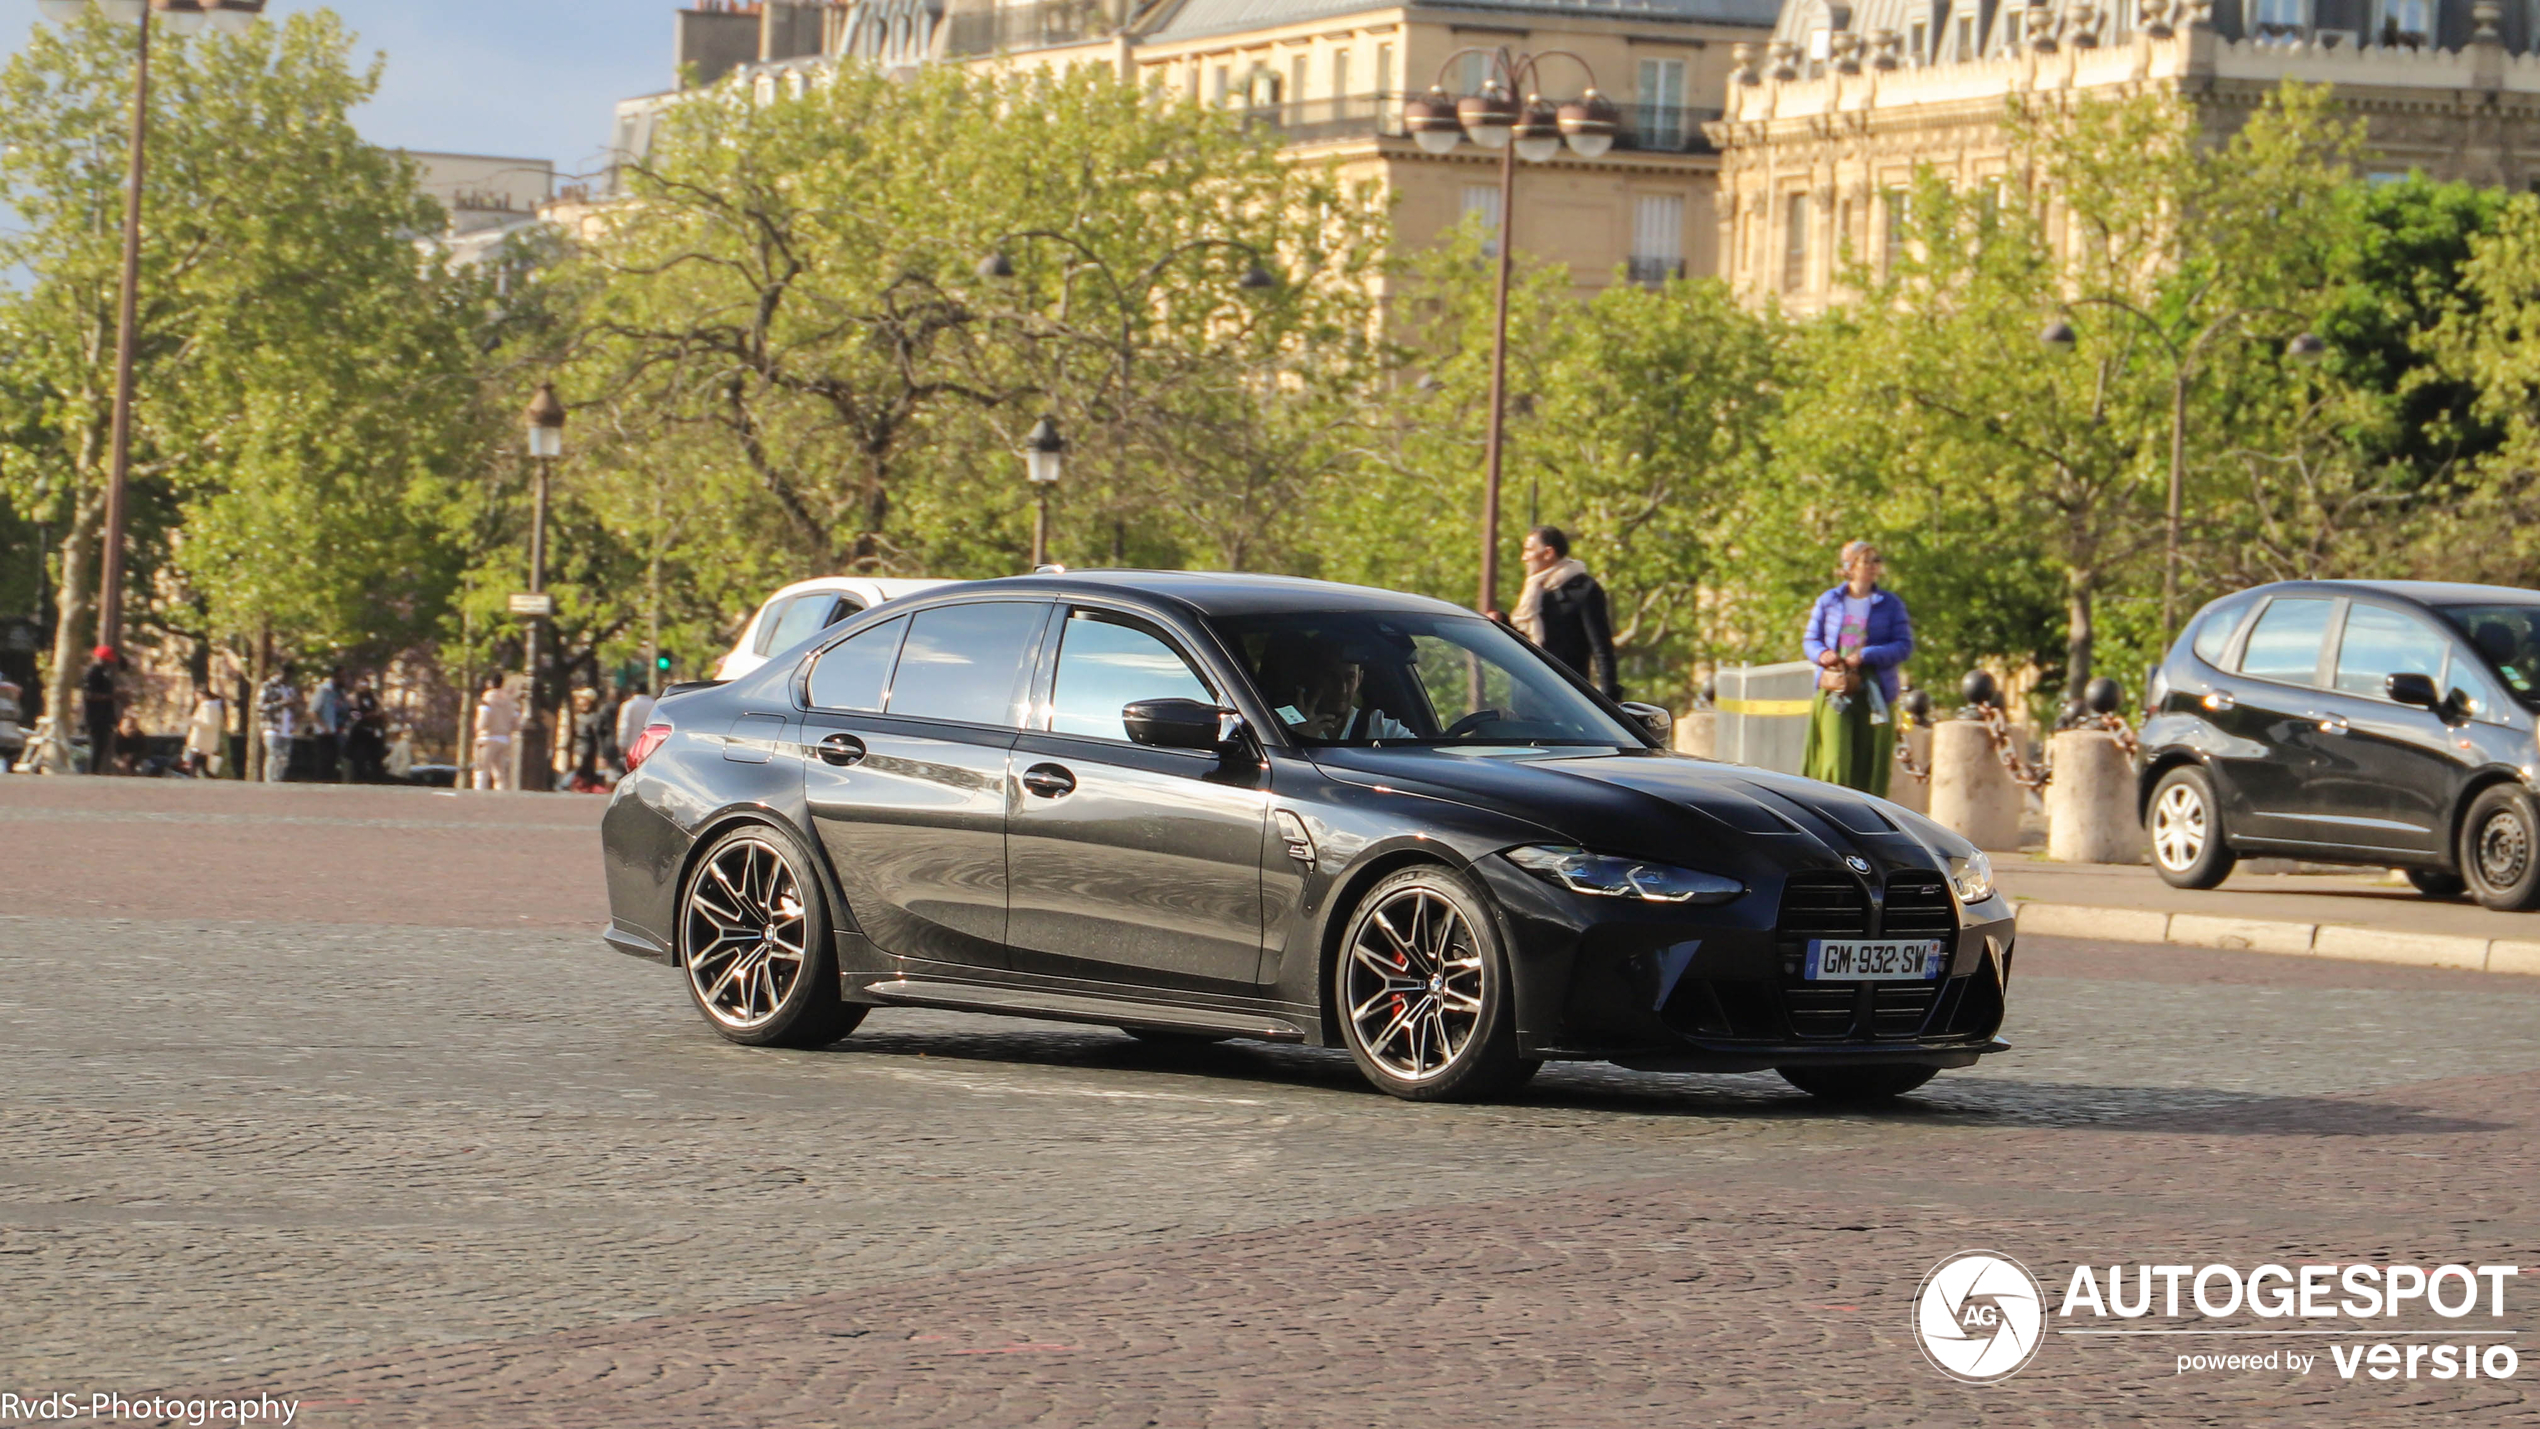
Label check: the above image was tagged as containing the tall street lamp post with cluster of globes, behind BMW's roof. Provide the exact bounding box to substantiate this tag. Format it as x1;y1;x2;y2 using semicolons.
1402;46;1621;612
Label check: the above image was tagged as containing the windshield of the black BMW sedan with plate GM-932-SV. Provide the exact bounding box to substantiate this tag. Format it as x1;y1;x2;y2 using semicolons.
1214;612;1641;749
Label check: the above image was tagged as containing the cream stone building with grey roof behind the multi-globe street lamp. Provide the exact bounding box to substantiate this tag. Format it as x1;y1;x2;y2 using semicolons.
615;0;1778;289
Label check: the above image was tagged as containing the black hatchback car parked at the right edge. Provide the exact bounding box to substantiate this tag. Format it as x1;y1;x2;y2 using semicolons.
2139;581;2540;909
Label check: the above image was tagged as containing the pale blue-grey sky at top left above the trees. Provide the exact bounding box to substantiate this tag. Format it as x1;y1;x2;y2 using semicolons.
0;0;681;175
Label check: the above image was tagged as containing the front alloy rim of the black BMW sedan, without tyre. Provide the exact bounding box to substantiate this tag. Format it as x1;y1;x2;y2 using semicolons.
1341;886;1483;1081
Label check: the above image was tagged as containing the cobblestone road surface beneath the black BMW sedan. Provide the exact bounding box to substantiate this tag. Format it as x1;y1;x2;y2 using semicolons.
0;779;2540;1426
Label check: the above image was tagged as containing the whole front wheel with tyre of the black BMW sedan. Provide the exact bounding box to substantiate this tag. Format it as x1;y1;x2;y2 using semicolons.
1334;868;1542;1102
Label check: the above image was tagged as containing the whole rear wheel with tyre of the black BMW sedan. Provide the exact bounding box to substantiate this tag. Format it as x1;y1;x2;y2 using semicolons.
678;825;864;1046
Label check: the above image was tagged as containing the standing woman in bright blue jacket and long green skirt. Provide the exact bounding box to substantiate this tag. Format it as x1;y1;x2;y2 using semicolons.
1801;541;1913;797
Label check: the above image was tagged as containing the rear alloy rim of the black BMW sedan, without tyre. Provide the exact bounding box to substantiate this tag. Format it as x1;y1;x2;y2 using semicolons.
681;838;810;1031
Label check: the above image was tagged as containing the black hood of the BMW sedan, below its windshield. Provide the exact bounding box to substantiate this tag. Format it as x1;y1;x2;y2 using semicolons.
1313;746;1976;873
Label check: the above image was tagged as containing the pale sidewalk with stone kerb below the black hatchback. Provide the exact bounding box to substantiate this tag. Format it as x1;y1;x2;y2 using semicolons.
1994;855;2540;975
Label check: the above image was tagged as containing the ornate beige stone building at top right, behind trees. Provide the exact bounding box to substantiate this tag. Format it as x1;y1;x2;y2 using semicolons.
1707;0;2540;312
